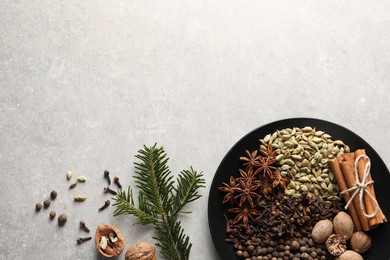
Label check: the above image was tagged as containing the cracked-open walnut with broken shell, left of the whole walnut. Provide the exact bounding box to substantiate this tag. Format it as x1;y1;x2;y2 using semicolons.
95;224;124;257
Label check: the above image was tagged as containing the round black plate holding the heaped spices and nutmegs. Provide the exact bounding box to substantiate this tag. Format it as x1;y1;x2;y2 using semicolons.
208;118;390;260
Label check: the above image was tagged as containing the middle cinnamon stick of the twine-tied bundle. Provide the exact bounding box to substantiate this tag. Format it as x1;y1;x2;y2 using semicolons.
340;153;370;231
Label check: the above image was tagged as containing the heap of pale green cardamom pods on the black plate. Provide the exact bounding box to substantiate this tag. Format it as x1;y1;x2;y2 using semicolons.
260;126;350;198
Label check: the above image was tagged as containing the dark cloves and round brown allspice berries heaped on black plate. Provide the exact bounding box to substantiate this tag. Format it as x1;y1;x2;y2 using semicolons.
226;188;342;259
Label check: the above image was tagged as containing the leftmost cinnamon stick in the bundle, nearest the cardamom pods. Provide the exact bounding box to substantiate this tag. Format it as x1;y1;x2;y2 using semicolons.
328;158;362;231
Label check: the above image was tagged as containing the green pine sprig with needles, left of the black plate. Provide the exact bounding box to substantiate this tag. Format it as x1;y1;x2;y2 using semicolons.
113;144;205;260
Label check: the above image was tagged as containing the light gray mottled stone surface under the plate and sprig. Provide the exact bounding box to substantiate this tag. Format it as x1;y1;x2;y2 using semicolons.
0;0;390;259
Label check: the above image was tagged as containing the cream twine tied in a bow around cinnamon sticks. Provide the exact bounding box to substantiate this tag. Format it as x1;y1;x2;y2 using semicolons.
340;154;379;218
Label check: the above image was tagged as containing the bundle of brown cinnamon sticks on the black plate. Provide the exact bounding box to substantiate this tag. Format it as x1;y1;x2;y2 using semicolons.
329;149;387;231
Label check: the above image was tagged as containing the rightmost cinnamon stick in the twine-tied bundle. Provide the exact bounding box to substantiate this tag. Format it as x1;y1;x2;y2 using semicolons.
355;149;387;228
